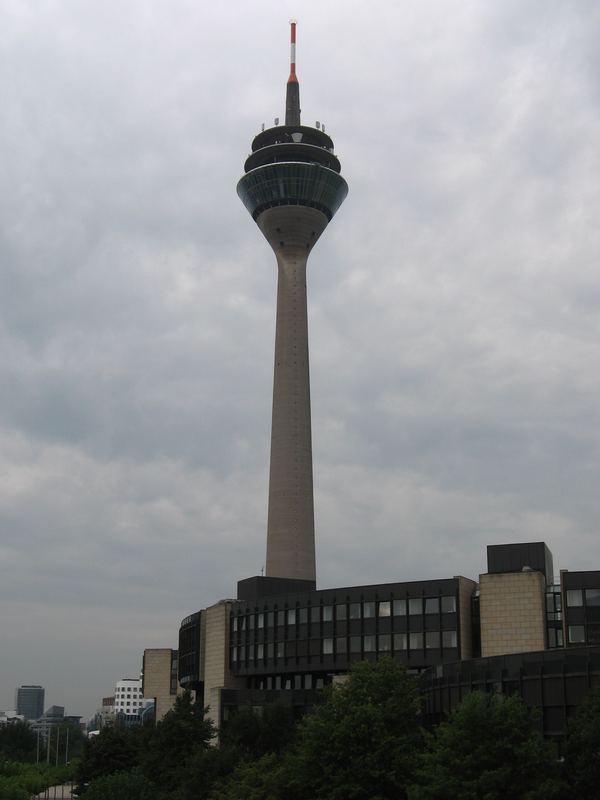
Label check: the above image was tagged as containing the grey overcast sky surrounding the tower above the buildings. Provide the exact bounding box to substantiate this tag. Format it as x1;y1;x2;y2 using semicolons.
0;0;600;717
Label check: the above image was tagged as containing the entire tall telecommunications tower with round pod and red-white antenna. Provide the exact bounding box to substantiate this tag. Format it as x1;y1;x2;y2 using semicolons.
237;22;348;581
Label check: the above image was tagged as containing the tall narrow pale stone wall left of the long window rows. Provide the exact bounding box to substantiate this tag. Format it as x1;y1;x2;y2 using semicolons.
200;600;244;728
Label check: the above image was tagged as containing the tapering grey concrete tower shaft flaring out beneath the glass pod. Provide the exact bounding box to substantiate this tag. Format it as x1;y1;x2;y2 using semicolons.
258;206;328;581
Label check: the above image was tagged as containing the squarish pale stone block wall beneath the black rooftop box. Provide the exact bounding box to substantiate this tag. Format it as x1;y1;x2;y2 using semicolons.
479;570;547;658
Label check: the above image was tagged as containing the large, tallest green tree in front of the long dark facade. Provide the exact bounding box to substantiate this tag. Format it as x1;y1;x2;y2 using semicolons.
284;658;423;800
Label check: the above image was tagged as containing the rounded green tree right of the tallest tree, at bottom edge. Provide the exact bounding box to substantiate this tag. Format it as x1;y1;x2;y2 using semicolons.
409;692;561;800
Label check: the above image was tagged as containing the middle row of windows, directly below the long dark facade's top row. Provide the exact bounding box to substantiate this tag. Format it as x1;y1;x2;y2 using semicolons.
231;631;457;663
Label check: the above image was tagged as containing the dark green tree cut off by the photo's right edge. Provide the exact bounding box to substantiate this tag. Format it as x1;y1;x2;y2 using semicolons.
565;690;600;800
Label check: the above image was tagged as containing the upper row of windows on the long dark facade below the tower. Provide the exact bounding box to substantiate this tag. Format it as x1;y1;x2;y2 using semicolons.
233;595;456;631
